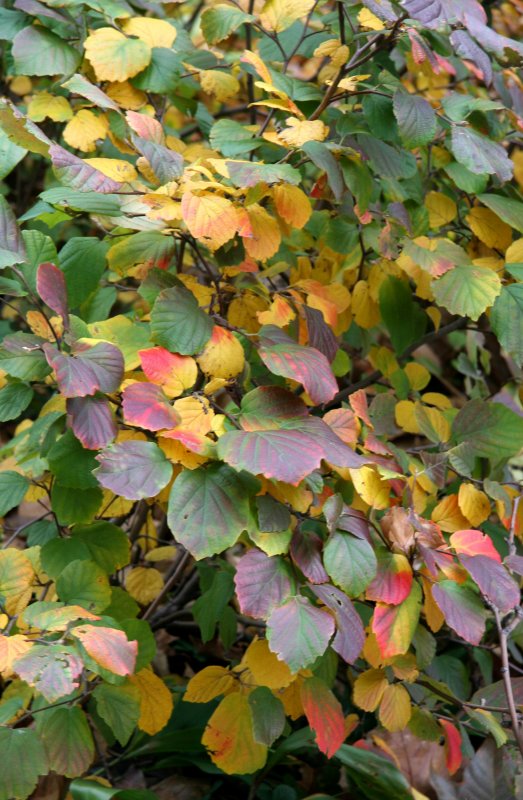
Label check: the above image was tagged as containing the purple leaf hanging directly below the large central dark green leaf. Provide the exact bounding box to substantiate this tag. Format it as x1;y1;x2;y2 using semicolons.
234;547;294;619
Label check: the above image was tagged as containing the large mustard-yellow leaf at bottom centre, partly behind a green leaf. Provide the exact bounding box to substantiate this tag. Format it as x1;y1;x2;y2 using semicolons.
202;693;267;775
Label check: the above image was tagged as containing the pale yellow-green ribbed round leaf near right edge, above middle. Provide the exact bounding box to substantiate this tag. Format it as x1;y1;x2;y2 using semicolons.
431;266;501;320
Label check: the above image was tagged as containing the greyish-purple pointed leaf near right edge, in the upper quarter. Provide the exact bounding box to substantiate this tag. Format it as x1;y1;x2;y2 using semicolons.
450;125;513;182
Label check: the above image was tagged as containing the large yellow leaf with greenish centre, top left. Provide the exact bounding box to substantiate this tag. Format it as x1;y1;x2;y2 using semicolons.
84;28;151;81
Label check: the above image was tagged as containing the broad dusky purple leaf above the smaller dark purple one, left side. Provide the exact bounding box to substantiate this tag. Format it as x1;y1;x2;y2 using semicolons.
42;341;124;397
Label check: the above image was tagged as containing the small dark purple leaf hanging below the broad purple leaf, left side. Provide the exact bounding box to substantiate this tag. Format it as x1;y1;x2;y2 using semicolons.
67;395;118;450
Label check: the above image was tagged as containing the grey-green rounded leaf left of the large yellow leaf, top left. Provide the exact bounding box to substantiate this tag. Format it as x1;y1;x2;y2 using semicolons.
12;25;80;75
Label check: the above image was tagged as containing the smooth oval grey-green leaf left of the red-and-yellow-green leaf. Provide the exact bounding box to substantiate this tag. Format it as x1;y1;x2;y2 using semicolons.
323;531;377;597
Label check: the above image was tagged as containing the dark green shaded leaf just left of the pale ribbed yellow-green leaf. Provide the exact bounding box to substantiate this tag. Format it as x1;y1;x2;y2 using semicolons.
379;276;427;354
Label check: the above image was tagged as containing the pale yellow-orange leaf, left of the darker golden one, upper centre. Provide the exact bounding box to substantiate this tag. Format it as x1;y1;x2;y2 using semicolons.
182;192;239;250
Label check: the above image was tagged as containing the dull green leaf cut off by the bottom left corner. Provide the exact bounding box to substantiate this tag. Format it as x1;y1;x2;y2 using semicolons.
0;727;49;800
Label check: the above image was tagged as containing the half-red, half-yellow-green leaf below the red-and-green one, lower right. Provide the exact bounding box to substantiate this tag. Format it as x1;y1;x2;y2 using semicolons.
372;581;421;658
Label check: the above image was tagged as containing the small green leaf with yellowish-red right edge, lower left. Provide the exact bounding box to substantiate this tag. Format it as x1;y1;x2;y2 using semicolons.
56;561;111;614
